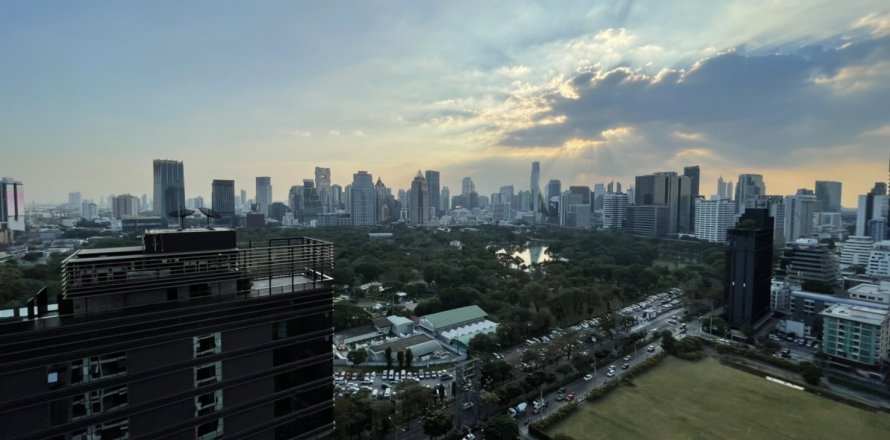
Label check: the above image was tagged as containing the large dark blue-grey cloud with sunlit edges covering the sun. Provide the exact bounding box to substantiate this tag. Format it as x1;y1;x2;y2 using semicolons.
500;37;890;165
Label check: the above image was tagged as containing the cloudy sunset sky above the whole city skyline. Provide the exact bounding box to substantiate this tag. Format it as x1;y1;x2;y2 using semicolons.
0;0;890;207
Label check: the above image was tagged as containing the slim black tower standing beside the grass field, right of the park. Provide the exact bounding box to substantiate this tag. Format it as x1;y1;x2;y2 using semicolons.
724;208;773;328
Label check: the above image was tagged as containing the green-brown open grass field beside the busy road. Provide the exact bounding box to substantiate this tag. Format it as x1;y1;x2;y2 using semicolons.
548;358;890;440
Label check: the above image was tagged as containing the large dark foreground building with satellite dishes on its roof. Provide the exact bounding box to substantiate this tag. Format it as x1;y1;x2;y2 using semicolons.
0;228;334;439
